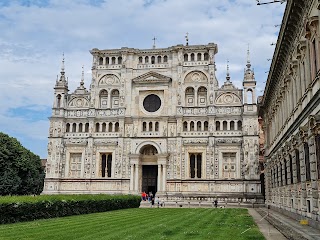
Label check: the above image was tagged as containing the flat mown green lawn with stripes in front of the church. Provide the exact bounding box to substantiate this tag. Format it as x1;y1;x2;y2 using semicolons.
0;208;264;240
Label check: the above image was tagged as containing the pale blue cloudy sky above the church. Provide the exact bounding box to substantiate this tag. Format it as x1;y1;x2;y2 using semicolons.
0;0;285;158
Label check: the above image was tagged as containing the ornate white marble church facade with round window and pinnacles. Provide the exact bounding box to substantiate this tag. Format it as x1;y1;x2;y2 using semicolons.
44;43;263;202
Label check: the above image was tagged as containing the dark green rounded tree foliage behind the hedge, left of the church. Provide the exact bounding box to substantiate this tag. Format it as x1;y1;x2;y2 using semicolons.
0;132;45;195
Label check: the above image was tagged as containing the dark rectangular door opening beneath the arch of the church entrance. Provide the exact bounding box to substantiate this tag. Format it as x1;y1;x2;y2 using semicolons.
142;165;158;194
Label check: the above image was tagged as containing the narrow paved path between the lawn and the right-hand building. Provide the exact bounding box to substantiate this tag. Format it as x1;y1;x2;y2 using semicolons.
248;208;287;240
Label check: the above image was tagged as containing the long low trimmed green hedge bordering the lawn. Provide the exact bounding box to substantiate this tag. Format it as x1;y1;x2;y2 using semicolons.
0;194;141;224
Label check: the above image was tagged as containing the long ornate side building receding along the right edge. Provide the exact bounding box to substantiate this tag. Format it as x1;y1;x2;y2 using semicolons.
260;0;320;227
